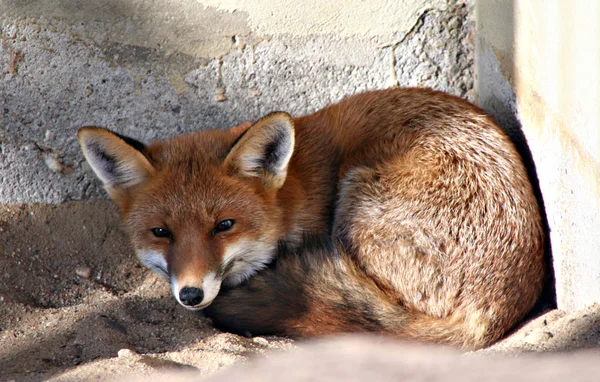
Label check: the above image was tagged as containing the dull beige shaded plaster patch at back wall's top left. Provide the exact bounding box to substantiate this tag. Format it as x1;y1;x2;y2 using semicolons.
2;0;257;57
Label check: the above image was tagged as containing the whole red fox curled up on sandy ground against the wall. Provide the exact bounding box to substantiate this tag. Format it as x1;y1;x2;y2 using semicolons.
78;88;545;349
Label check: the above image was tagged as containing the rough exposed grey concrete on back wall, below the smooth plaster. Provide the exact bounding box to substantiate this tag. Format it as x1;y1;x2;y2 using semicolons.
0;2;478;203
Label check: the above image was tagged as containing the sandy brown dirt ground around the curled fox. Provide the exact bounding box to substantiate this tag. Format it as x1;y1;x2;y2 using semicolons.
0;201;600;381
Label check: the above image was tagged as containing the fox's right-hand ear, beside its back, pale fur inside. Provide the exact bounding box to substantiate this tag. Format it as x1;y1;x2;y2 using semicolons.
224;113;294;188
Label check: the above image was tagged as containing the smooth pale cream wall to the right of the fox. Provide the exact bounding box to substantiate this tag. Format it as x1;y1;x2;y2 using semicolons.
477;0;600;310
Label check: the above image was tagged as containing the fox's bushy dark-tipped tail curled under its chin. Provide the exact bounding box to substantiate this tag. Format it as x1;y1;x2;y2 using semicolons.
205;237;484;348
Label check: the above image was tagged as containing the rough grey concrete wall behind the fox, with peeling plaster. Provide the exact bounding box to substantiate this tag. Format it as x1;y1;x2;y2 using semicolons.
0;0;474;203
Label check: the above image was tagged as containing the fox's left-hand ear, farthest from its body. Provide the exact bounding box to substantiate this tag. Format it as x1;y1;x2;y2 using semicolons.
77;127;154;202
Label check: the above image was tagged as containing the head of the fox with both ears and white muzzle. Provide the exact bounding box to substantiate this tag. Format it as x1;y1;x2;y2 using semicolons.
78;113;294;310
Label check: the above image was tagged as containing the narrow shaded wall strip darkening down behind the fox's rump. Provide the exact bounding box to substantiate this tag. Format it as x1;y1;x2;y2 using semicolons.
476;0;556;315
